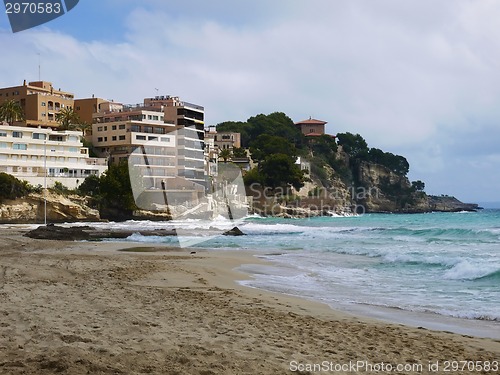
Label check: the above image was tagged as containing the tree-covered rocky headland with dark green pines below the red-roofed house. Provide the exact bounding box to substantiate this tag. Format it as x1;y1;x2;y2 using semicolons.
217;112;440;211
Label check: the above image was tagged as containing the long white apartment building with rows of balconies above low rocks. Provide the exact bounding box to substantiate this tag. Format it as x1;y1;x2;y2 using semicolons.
0;125;107;189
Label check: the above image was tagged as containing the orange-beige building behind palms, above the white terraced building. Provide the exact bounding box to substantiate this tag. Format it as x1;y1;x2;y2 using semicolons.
0;81;74;128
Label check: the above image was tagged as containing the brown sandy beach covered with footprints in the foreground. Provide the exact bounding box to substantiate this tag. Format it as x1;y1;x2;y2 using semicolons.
0;228;500;375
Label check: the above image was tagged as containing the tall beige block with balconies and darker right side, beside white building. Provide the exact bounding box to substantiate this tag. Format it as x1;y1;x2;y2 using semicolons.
90;97;206;189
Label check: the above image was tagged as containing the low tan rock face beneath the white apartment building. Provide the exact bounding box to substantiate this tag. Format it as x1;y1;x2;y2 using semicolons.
0;193;101;224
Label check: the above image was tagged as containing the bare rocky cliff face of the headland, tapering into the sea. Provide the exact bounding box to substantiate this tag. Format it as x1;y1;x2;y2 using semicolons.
284;148;479;217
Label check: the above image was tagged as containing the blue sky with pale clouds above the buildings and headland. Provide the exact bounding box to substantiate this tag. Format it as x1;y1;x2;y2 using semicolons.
0;0;500;206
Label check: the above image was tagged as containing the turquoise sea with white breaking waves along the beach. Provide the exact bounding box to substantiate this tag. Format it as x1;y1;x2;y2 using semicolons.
13;209;500;339
